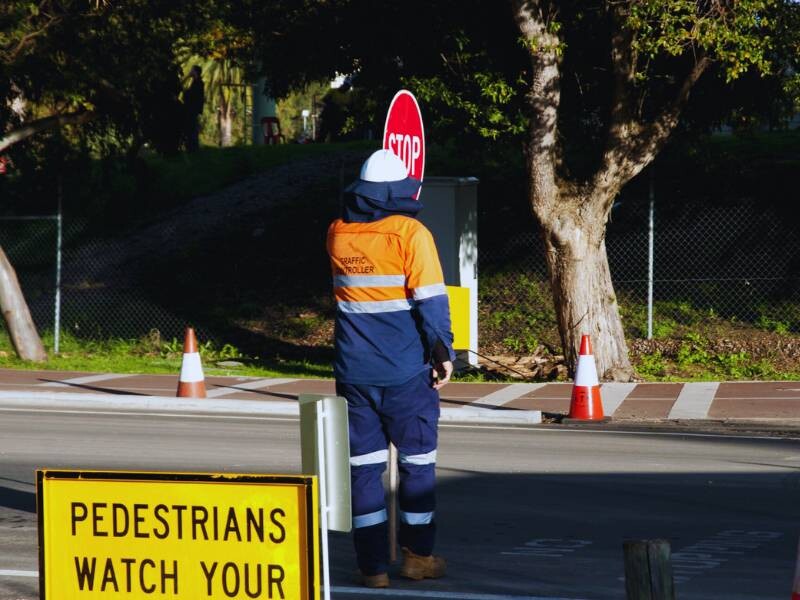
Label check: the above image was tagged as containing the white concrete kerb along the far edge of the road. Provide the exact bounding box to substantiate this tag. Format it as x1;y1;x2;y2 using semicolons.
0;391;542;425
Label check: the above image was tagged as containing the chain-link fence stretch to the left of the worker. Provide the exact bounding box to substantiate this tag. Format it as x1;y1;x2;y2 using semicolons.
0;216;190;350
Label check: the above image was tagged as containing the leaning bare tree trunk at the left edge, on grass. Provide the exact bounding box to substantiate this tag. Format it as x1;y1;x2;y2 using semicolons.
0;248;47;362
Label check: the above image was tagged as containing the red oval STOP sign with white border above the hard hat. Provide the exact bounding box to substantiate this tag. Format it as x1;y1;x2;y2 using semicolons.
383;90;425;196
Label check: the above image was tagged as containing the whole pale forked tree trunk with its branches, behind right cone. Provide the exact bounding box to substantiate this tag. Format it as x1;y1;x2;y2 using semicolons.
512;0;710;381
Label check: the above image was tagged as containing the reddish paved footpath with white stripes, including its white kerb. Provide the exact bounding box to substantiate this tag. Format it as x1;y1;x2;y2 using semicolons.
0;369;800;426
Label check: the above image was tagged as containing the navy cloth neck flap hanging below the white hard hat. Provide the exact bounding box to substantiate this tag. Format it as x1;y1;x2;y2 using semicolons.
342;177;422;223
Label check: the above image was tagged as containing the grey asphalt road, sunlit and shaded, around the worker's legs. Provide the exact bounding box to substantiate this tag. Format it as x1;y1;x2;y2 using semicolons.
0;409;800;600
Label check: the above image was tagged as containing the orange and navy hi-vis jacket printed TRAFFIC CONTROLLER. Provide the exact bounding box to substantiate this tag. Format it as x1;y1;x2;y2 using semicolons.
328;215;455;386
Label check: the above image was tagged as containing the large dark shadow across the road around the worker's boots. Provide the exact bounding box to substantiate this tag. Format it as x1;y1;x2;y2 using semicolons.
330;469;798;600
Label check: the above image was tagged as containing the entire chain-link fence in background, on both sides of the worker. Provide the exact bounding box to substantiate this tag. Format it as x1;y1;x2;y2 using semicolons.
0;201;800;353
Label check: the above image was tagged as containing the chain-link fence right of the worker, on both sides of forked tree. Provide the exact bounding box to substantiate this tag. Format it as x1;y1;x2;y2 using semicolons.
479;196;800;352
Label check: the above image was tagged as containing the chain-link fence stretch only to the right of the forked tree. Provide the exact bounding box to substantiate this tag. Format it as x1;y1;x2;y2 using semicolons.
607;203;800;332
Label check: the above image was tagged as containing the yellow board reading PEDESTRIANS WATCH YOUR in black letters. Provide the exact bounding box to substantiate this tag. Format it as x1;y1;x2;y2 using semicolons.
37;470;320;600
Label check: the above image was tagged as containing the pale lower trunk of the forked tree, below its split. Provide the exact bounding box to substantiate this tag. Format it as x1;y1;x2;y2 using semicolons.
540;196;633;381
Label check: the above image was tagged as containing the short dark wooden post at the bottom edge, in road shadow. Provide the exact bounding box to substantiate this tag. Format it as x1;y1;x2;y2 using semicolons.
622;540;675;600
